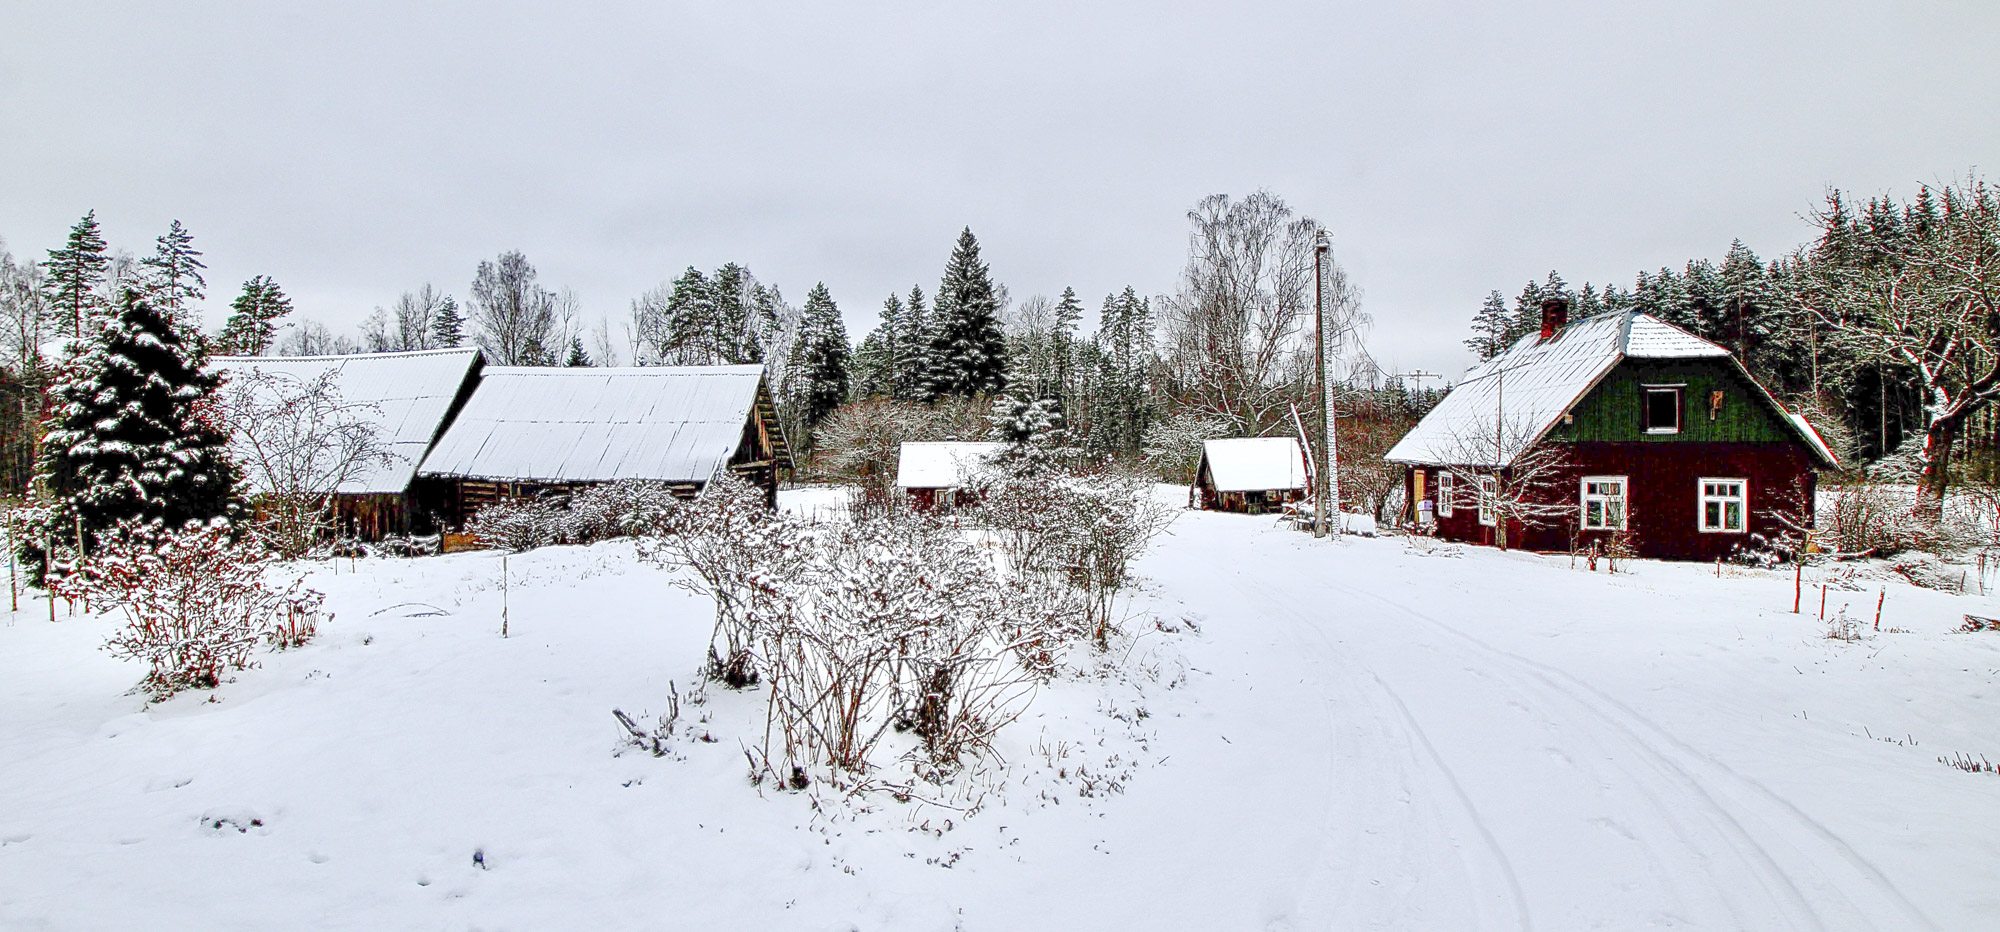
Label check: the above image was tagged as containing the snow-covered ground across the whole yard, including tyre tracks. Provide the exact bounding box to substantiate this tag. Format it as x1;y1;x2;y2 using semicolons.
0;492;2000;930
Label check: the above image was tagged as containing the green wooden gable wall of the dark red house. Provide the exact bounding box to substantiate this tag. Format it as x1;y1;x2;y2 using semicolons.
1548;360;1798;444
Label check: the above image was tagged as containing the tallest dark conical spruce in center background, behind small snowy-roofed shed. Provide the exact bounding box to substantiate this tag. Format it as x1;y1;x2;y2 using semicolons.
924;226;1006;398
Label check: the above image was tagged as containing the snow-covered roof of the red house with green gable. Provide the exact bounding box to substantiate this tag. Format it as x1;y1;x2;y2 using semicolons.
1386;310;1834;466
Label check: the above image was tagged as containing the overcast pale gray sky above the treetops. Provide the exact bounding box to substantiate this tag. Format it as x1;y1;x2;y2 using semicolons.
0;0;2000;376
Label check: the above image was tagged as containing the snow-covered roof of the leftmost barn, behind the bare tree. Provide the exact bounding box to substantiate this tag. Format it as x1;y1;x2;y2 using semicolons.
210;348;480;494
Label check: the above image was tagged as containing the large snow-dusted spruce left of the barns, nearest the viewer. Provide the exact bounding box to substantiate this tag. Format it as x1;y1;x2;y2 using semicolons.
26;290;240;574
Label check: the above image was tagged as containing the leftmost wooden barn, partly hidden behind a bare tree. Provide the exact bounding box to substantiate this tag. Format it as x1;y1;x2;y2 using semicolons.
210;348;484;540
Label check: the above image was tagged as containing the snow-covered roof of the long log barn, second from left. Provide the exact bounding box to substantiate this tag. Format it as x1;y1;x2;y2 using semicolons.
420;366;764;482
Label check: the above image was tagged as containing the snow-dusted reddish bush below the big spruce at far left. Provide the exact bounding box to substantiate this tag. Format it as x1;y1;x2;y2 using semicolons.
54;520;324;698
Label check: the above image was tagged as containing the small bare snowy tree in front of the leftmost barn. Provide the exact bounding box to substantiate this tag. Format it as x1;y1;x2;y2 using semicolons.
226;372;390;558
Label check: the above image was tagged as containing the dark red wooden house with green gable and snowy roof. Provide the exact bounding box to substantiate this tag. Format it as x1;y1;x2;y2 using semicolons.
1388;302;1836;560
